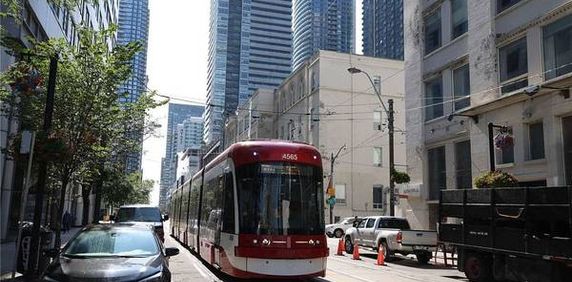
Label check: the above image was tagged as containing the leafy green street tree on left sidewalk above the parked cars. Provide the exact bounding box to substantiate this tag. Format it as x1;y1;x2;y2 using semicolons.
0;27;162;246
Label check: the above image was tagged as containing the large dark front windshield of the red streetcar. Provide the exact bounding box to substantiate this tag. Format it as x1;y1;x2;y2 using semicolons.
237;163;325;235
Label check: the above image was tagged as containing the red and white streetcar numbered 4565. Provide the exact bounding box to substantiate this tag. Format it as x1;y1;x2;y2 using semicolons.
170;141;328;278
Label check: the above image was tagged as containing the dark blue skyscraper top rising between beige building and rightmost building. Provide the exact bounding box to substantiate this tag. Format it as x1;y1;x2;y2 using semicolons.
362;0;403;60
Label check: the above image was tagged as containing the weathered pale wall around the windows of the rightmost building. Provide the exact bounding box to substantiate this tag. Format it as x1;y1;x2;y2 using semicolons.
404;0;572;228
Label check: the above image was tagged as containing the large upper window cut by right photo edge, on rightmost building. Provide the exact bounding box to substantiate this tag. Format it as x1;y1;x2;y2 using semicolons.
544;15;572;79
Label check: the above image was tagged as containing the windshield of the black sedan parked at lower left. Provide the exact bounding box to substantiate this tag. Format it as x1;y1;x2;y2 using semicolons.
64;228;159;257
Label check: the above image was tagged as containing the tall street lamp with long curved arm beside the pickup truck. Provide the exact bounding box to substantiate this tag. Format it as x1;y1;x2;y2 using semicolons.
348;67;395;216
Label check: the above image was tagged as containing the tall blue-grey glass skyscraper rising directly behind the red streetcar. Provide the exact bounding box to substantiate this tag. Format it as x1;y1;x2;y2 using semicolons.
204;0;292;144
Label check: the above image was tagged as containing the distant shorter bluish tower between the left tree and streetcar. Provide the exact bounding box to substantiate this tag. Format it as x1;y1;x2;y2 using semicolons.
159;103;205;207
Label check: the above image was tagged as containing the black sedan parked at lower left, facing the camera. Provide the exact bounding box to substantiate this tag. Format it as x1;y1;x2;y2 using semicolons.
43;224;179;282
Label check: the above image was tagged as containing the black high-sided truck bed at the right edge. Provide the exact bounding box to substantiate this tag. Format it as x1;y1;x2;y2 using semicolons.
439;187;572;260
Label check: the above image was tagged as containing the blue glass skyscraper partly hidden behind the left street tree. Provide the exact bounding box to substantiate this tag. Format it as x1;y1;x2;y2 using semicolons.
117;0;149;172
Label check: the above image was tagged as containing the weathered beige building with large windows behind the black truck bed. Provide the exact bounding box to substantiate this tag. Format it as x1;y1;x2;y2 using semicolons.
404;0;572;229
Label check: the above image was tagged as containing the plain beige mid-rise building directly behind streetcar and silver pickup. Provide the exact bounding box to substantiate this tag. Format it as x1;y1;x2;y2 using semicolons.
223;51;406;222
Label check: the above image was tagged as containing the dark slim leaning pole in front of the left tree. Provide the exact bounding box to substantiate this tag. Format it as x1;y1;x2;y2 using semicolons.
28;54;60;275
